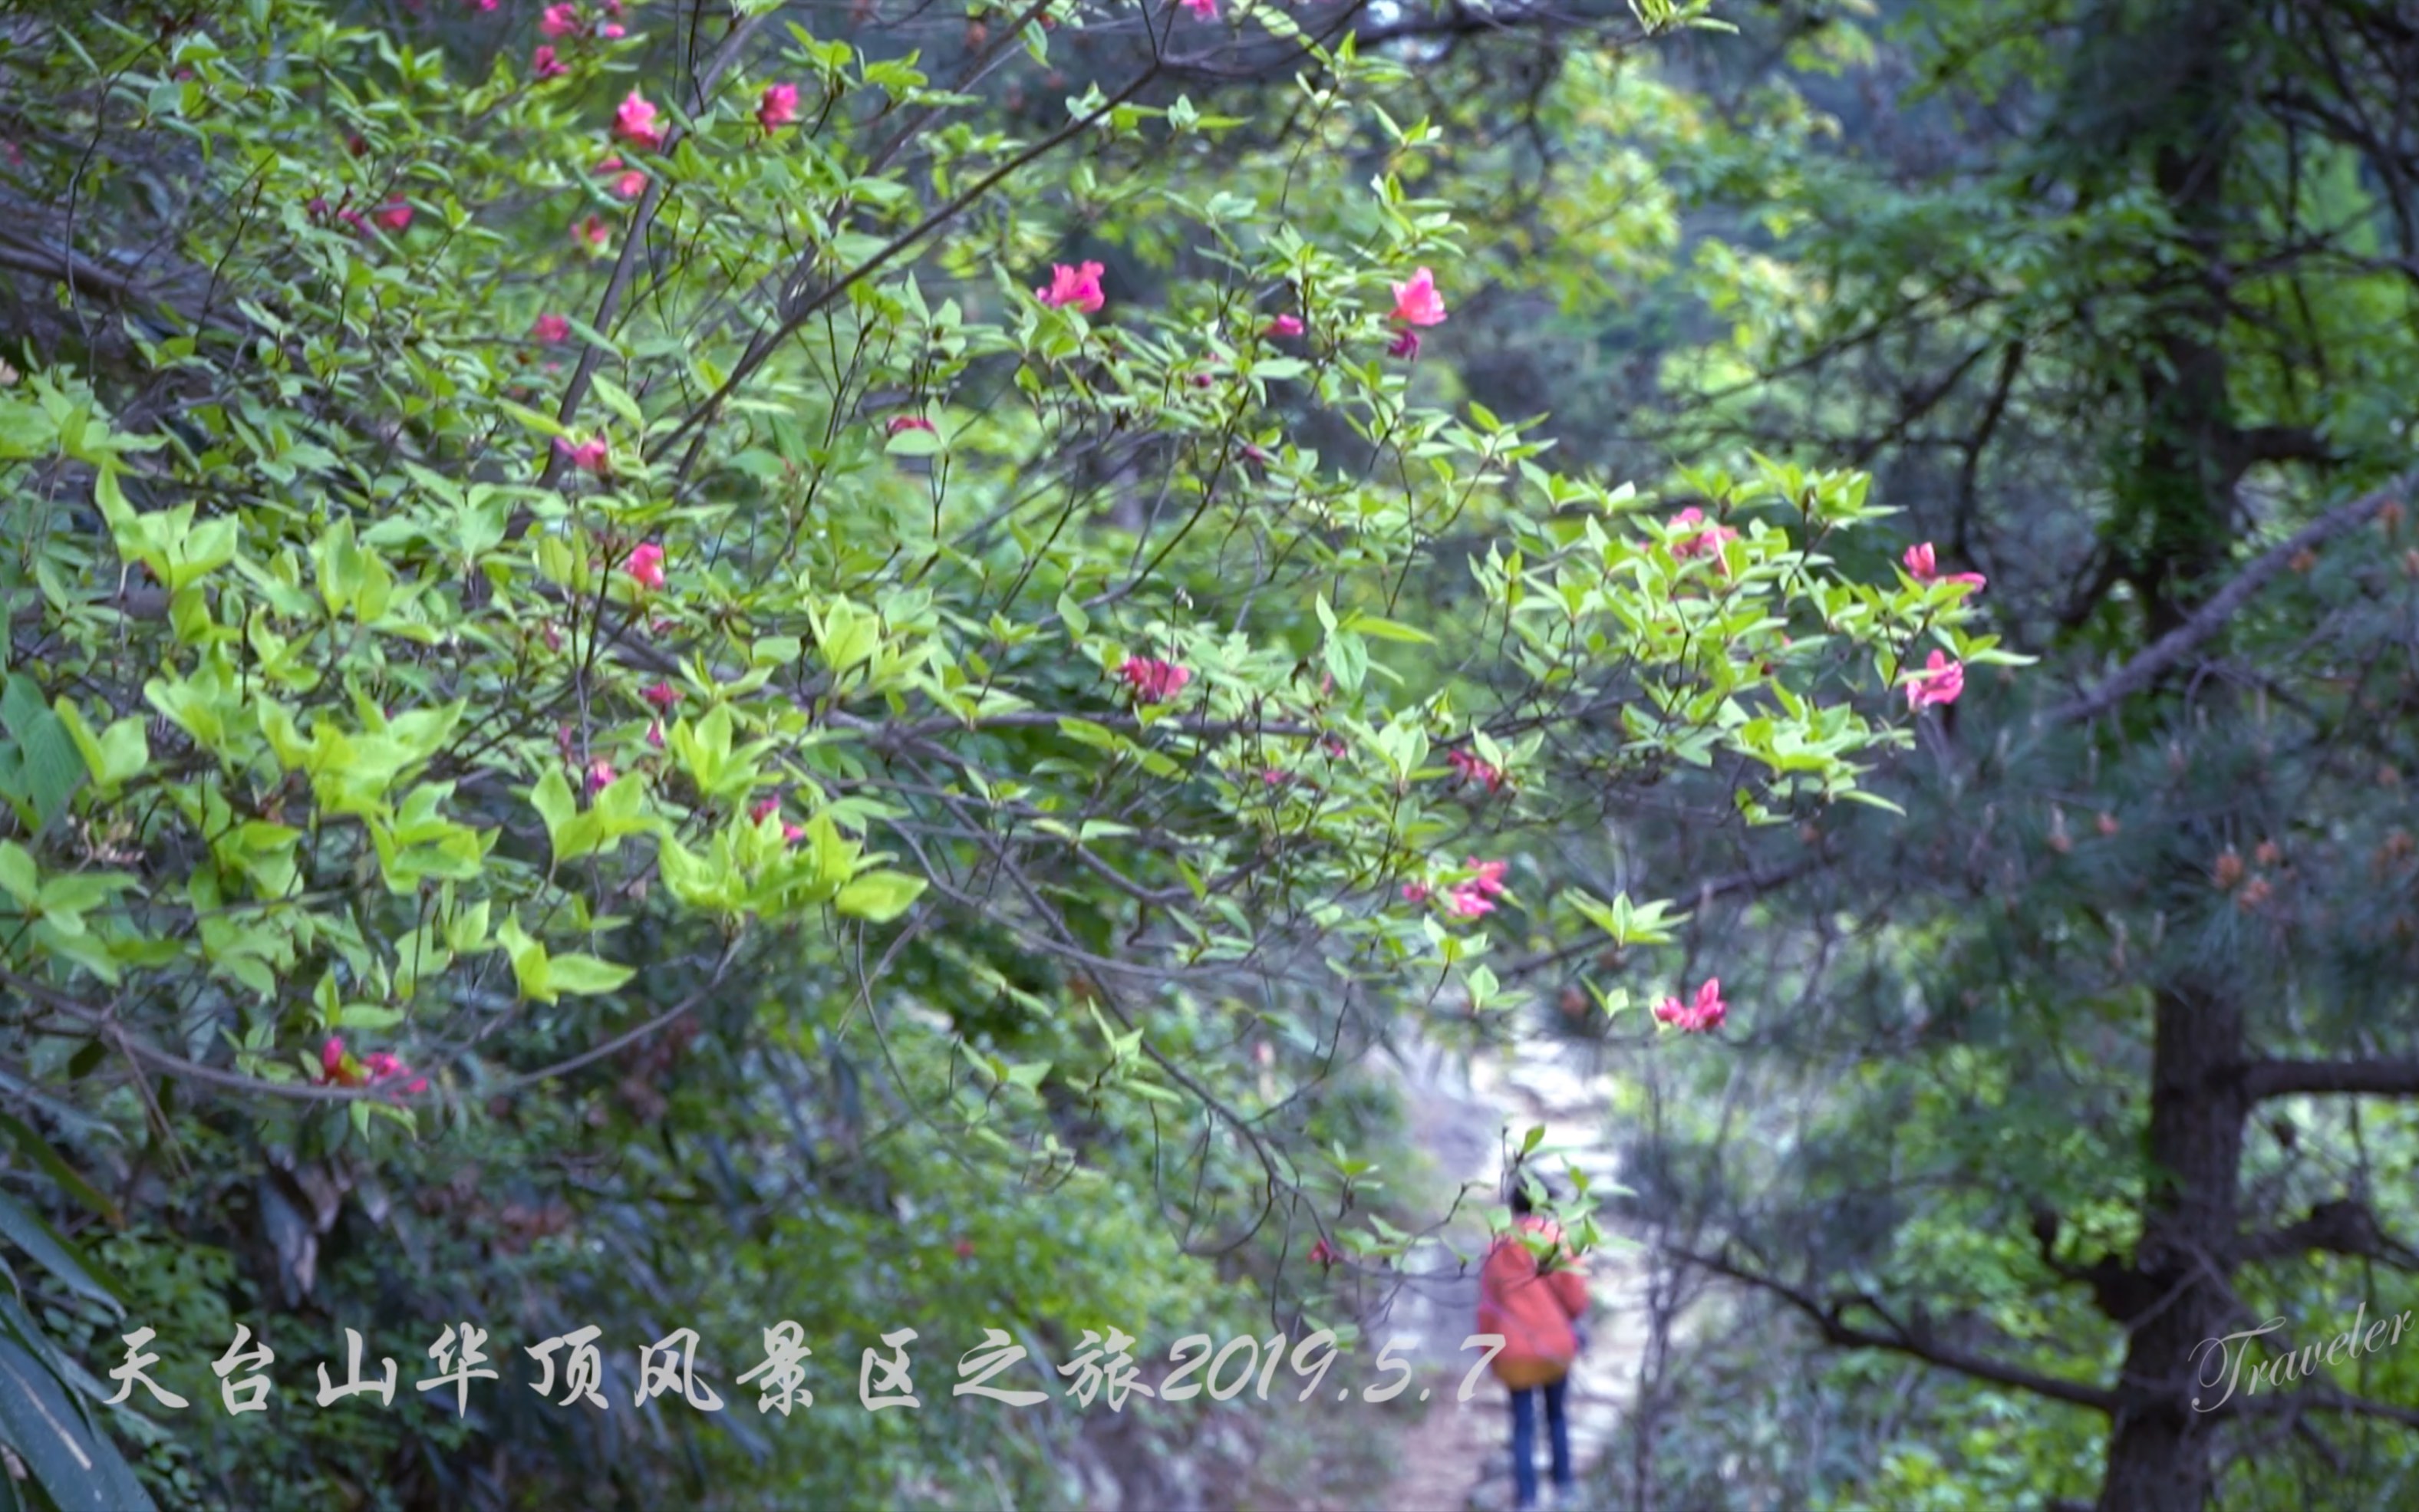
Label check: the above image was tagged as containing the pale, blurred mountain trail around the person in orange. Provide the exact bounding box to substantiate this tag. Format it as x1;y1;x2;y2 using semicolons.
1369;1026;1647;1512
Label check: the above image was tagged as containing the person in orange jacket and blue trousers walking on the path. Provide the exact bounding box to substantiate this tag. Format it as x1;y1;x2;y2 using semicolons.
1478;1176;1587;1510
